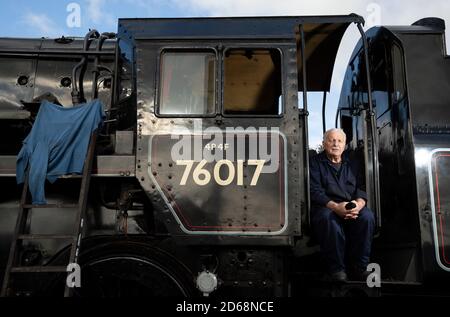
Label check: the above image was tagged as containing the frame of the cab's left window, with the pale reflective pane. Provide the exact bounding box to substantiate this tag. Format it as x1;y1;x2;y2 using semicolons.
154;46;220;118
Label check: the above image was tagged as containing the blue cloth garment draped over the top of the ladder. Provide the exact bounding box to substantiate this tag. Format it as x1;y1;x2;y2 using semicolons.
16;100;105;204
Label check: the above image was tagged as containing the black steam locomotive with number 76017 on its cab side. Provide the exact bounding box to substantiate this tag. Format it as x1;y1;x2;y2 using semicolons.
0;14;450;297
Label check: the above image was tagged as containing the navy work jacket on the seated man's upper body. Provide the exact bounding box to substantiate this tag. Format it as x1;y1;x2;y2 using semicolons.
309;152;367;207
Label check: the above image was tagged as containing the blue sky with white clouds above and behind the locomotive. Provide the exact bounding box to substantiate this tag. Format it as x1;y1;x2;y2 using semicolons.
0;0;450;148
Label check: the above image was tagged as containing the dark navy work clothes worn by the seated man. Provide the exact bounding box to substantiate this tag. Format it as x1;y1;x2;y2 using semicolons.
310;152;375;273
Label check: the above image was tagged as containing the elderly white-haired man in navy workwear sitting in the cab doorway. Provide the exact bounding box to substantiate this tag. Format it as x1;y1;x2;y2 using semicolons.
310;129;375;281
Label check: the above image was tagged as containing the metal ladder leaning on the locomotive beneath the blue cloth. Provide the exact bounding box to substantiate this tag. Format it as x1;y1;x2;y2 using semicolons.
1;132;97;297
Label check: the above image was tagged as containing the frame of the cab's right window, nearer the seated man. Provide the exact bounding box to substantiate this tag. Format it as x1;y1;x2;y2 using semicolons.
219;44;286;118
